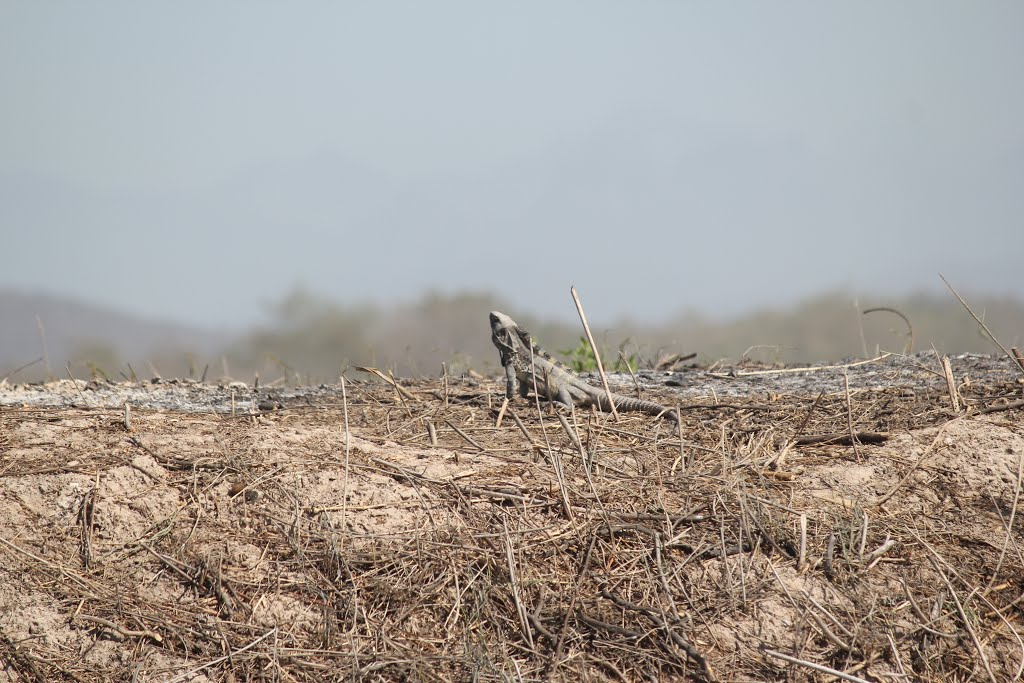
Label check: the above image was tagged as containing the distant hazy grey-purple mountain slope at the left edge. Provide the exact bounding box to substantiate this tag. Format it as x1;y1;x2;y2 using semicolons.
0;290;233;382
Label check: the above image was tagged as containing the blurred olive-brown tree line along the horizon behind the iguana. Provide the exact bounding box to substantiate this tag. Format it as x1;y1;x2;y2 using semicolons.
14;289;1024;385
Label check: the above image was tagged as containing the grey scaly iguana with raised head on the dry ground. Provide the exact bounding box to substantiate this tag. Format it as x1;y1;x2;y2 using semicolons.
490;310;677;420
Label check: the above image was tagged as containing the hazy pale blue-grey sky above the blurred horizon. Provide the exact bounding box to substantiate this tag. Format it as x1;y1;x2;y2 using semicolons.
0;0;1024;325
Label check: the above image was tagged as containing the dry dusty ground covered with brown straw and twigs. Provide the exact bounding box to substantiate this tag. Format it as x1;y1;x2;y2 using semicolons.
0;355;1024;681
